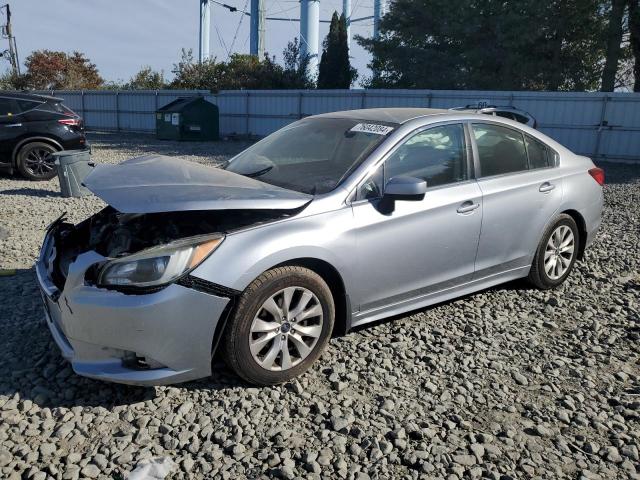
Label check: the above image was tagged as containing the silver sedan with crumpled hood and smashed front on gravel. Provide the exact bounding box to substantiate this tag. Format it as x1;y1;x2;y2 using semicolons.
36;108;604;385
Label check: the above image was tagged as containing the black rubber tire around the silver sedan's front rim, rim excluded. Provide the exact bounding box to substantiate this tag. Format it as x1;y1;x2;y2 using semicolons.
222;266;335;385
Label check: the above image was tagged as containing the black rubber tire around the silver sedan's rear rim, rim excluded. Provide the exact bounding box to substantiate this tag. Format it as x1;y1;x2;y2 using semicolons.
529;213;580;290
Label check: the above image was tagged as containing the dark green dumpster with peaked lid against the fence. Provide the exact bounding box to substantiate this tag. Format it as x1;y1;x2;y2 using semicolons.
156;96;220;141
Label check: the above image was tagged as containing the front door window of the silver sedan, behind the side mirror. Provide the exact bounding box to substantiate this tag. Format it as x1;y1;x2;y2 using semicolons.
384;124;467;187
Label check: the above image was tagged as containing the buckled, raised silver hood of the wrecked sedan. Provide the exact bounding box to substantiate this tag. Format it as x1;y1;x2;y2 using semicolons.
83;155;313;213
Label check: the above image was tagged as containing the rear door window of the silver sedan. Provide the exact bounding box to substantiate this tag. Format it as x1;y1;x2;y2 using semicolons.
472;124;527;177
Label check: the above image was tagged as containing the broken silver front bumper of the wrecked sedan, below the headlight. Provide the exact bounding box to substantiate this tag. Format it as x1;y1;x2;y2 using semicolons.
36;227;230;385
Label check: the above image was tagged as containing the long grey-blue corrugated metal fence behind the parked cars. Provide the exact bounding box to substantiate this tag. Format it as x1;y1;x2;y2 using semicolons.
43;90;640;161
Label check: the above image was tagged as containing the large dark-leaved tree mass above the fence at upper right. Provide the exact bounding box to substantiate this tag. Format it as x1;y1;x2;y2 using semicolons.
357;0;611;91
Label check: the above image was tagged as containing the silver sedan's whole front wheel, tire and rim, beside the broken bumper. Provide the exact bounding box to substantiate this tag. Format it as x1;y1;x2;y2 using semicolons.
223;266;335;385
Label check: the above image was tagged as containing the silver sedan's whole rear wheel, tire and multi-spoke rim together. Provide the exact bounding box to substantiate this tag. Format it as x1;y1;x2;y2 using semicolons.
529;214;580;290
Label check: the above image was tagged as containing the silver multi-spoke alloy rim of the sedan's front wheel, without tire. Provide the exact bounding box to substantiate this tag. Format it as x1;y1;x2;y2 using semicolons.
249;287;323;371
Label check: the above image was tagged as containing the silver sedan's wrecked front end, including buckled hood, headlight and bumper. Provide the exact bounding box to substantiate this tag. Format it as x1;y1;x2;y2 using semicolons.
36;155;312;385
